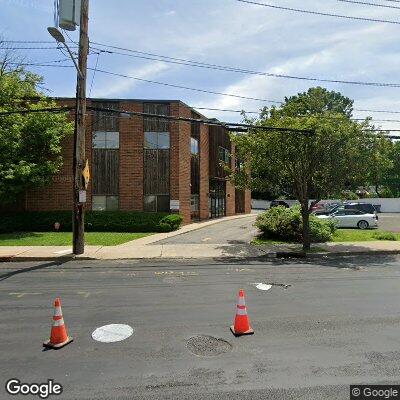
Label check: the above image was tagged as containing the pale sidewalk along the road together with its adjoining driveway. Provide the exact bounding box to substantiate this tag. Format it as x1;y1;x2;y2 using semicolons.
0;214;400;261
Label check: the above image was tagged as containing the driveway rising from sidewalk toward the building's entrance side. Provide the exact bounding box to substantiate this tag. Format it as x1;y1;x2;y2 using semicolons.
154;213;258;244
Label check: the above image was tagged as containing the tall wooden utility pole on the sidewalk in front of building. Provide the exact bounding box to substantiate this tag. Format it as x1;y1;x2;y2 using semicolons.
72;0;89;255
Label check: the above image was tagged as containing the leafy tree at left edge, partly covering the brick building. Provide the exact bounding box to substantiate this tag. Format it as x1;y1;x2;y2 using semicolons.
0;47;73;203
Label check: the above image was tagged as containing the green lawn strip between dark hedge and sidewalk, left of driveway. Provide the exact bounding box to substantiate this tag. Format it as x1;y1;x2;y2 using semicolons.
0;232;152;246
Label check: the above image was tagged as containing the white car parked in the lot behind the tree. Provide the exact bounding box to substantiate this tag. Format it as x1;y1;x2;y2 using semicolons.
317;207;378;229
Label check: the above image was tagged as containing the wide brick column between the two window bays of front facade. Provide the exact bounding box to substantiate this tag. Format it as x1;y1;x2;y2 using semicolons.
119;102;144;211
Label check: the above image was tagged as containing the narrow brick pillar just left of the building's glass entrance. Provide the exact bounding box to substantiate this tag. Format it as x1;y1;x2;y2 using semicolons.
200;125;210;220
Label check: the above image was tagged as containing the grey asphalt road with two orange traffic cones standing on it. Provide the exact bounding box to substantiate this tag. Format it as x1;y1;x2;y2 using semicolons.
0;256;400;400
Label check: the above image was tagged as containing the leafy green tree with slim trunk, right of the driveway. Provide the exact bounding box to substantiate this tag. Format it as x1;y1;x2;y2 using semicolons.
231;87;371;251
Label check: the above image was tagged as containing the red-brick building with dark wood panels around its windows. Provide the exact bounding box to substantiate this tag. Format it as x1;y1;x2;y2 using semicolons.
24;98;251;223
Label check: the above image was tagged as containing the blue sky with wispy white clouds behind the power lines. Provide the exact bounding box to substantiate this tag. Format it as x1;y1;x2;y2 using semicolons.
0;0;400;129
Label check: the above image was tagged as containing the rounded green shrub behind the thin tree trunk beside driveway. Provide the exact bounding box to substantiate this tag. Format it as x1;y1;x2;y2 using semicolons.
255;206;336;243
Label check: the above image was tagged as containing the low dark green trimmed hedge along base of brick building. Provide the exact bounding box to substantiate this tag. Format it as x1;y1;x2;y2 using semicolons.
0;211;182;233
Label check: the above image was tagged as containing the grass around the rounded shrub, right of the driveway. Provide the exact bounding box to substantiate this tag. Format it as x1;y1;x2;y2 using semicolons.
252;229;400;245
